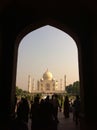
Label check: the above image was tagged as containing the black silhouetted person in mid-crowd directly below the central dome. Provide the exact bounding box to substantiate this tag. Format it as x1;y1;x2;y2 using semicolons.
40;96;57;130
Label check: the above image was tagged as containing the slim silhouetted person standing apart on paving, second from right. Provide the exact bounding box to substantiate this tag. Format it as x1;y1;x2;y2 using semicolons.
63;96;70;118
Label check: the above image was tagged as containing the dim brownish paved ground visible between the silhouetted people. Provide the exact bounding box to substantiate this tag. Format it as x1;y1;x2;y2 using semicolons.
29;112;80;130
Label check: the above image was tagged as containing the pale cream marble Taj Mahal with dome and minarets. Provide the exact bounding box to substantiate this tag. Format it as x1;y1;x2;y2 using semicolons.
28;69;66;94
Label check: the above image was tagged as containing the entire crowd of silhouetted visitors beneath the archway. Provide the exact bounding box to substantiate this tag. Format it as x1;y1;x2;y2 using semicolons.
11;94;80;130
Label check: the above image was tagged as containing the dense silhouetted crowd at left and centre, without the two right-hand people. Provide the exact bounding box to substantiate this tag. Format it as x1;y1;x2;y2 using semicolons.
12;95;59;130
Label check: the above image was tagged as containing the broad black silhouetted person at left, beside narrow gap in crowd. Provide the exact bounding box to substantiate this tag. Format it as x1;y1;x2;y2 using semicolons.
11;98;29;130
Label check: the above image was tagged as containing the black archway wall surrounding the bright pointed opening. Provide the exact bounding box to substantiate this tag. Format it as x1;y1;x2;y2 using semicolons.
0;0;97;130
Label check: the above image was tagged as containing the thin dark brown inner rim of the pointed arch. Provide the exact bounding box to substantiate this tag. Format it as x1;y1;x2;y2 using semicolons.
13;18;84;124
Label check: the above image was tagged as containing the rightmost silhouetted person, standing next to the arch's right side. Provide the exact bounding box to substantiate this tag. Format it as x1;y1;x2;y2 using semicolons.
73;95;80;125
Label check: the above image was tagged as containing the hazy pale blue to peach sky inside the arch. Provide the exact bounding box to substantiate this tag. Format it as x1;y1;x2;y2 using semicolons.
16;25;79;90
